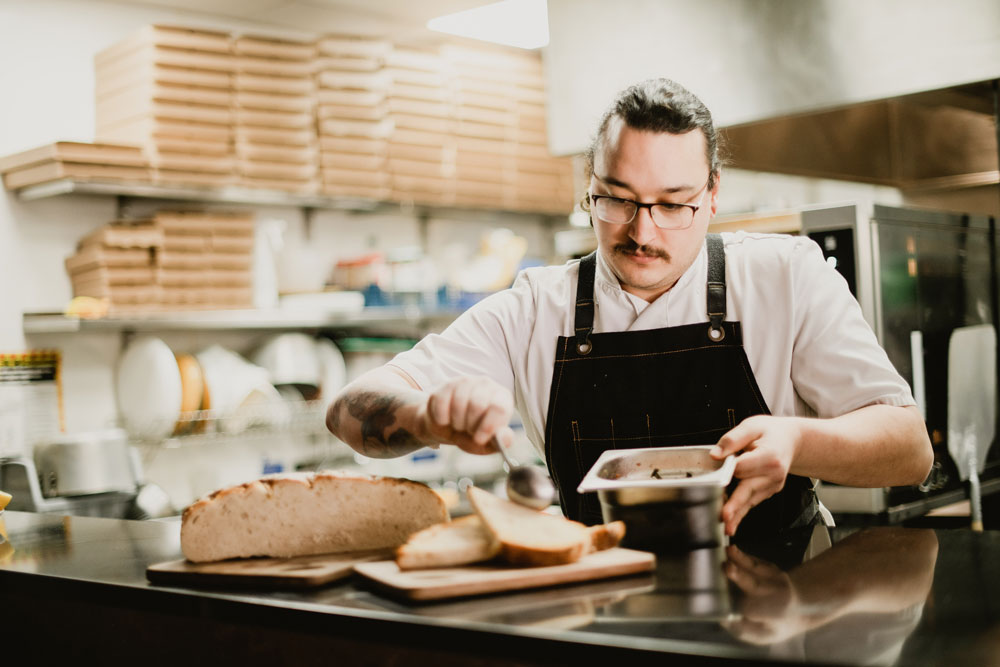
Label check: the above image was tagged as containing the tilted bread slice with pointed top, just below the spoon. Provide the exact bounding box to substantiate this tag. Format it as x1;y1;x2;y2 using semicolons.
468;486;593;566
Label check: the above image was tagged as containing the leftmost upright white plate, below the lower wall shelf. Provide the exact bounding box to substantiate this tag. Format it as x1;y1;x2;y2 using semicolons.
115;336;182;440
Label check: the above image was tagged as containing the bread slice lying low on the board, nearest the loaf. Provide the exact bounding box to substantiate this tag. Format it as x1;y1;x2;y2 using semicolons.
396;514;500;570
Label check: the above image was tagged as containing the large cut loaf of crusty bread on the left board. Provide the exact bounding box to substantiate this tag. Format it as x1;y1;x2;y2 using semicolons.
181;471;448;563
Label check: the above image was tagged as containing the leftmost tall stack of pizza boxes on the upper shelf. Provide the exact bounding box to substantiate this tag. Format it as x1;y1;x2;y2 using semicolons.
95;25;236;186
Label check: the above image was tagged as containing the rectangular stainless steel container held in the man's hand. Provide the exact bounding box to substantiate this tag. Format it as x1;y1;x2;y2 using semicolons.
577;445;736;552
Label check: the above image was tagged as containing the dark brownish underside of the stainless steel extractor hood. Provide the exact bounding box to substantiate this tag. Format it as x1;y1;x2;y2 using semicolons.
724;81;1000;198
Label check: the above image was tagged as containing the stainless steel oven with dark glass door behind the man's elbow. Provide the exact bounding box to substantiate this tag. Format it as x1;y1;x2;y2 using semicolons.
801;202;1000;522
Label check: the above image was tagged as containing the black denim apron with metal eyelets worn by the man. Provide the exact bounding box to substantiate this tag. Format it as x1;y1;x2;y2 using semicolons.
545;234;819;538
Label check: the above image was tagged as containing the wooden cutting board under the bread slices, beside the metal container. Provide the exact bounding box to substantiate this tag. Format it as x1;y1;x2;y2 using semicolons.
354;548;656;600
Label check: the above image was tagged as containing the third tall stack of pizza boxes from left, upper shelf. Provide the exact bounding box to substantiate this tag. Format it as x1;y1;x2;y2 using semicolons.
315;35;392;199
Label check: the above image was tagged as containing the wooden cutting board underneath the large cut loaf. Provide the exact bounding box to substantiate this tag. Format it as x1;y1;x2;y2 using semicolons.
146;549;391;588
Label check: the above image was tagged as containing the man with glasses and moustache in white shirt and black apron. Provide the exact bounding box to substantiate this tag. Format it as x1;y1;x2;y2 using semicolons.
327;79;932;537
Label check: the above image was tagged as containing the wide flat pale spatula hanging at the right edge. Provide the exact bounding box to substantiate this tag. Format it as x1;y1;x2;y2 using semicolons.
948;324;997;530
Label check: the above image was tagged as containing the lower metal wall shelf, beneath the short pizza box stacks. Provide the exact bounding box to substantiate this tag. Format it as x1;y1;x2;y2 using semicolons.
23;307;459;334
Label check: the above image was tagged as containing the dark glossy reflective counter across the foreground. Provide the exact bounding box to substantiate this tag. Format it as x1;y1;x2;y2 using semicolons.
0;511;1000;666
